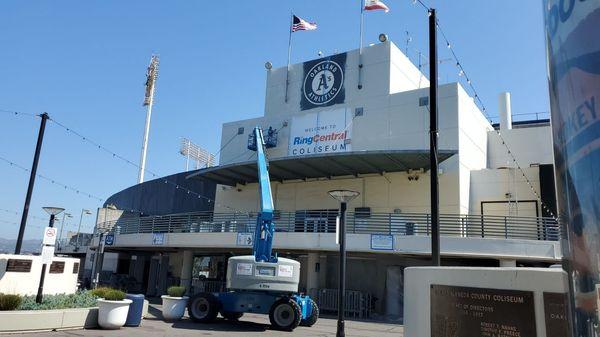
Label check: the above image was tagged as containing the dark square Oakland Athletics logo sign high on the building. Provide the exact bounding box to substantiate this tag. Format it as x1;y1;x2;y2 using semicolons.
300;54;346;110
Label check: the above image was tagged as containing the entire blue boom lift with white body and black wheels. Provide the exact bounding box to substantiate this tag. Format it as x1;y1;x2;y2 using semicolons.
188;127;319;331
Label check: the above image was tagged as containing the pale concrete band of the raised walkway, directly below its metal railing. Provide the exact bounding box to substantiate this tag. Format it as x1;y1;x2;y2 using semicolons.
109;232;562;262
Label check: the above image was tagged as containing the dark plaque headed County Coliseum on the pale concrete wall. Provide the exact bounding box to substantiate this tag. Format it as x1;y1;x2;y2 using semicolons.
430;285;537;337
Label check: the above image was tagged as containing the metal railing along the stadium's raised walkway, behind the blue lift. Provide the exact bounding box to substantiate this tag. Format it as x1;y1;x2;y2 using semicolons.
97;211;561;241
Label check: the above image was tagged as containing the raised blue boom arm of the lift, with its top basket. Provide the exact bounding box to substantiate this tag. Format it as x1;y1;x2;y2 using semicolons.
248;127;277;262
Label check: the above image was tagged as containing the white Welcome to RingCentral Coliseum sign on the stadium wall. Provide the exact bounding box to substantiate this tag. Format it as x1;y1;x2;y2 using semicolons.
288;109;352;156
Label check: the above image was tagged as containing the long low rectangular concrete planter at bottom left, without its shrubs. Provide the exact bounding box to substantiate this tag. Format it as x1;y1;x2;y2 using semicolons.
0;308;98;333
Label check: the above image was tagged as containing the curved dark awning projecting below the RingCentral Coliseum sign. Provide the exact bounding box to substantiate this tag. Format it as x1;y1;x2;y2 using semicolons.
187;150;457;186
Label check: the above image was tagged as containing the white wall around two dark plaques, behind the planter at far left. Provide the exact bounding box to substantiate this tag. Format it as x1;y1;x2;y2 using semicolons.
0;254;83;295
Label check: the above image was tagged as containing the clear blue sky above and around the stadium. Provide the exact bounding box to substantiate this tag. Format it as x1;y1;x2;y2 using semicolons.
0;0;549;242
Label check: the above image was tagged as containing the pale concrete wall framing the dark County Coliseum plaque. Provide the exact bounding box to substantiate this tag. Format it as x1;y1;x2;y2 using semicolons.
404;267;568;337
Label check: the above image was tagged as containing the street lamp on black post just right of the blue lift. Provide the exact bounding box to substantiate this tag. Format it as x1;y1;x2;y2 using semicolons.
327;190;360;337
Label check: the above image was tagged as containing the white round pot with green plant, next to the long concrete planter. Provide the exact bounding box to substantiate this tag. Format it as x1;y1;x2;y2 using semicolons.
95;289;131;329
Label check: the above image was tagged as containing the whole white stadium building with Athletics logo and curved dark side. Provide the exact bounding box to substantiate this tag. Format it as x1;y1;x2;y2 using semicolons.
86;41;561;319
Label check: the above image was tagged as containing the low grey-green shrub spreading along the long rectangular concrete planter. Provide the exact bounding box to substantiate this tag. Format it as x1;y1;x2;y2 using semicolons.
19;290;98;310
